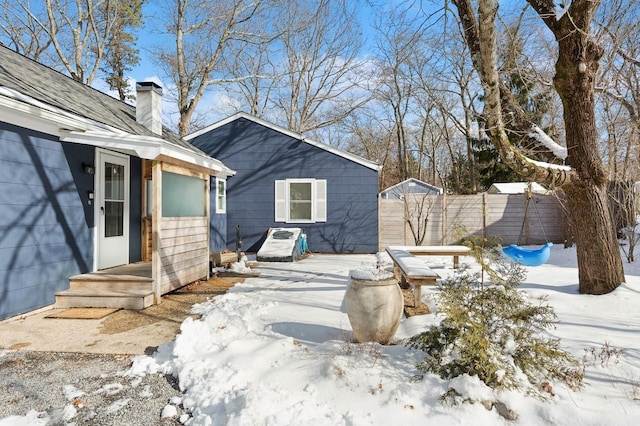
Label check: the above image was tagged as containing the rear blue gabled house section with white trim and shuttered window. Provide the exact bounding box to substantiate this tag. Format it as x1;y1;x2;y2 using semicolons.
185;112;380;253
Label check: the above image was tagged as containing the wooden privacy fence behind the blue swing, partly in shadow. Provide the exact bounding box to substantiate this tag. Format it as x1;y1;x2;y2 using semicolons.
378;193;567;250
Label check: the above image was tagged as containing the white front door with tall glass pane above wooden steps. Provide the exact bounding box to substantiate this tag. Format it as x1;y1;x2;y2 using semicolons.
96;150;129;269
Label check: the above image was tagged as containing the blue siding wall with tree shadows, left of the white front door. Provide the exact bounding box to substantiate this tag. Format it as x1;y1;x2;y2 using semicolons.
0;123;94;319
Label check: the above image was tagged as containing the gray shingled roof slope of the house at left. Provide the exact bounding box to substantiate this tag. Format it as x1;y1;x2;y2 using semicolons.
0;44;203;154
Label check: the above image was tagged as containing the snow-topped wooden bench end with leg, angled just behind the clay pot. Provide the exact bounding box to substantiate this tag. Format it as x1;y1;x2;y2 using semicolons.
387;247;440;308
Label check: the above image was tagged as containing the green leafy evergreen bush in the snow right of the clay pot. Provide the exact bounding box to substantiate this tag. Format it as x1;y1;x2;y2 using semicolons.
407;240;583;397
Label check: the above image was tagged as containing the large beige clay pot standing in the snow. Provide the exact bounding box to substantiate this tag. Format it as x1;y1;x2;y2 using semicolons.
345;274;404;345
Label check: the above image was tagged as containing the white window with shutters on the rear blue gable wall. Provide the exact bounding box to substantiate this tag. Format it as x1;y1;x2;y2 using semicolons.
275;179;327;223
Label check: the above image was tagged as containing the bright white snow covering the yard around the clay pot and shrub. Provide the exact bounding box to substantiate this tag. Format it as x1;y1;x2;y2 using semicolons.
3;245;640;426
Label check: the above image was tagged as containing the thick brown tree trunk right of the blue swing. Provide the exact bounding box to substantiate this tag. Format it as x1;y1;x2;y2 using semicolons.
554;13;625;294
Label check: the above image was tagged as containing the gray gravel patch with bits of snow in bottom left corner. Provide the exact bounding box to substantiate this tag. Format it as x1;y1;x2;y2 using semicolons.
0;351;186;426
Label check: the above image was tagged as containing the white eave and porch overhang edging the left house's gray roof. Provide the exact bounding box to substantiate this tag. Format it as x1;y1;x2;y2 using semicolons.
0;86;235;178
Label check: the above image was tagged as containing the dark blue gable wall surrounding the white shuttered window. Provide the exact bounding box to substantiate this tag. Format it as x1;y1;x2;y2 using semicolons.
190;118;378;253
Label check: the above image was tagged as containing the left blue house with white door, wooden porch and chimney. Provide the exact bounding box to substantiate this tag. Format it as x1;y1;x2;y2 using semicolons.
0;45;233;319
